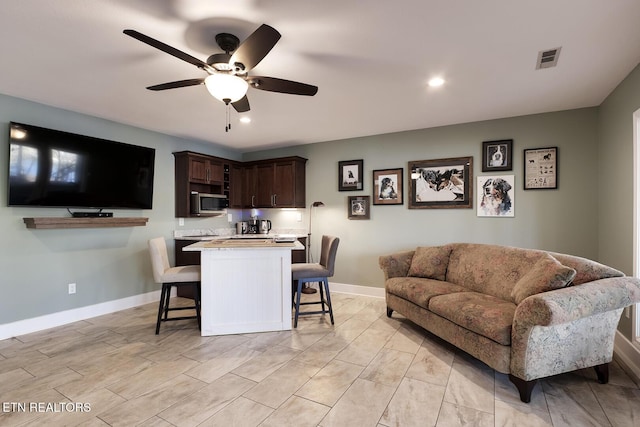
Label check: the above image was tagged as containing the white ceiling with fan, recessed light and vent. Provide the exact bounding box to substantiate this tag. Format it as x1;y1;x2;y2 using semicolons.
0;0;640;151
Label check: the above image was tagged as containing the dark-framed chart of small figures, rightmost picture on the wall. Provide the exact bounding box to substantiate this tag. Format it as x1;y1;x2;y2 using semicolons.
524;147;558;190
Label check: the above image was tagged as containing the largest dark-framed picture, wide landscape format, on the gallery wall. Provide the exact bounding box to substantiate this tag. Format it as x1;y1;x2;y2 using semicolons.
408;157;473;209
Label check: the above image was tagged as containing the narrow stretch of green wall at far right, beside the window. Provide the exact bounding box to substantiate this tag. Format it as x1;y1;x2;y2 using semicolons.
597;66;640;339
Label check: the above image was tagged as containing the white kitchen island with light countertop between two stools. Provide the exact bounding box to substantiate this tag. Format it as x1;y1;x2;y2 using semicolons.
183;238;304;336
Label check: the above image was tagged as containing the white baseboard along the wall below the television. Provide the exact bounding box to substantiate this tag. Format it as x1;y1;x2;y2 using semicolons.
0;290;162;340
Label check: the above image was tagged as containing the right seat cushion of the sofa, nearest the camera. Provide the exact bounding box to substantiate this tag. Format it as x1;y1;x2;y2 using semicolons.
429;292;516;345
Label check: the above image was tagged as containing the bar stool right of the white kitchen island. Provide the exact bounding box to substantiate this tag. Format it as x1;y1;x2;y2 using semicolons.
291;236;340;328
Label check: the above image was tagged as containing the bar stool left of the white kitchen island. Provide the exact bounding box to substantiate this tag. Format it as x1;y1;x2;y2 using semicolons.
149;237;201;335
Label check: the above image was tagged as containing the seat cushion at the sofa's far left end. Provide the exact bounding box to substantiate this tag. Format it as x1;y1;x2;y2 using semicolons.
385;277;468;309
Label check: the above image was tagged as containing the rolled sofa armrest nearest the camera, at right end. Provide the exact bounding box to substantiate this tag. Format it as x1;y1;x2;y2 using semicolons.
510;277;640;381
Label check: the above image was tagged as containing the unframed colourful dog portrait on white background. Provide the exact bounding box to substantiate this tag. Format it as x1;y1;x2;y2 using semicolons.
478;175;515;217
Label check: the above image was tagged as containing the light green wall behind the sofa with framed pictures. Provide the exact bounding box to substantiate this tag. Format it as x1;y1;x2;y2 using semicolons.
244;108;598;287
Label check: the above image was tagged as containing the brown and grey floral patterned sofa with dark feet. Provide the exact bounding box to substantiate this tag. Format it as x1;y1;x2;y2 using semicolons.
379;243;640;403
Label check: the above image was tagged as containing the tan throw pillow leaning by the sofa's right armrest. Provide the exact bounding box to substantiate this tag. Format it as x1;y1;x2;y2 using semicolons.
511;254;576;304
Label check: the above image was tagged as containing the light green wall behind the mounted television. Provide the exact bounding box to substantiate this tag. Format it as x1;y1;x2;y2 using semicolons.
0;95;240;324
